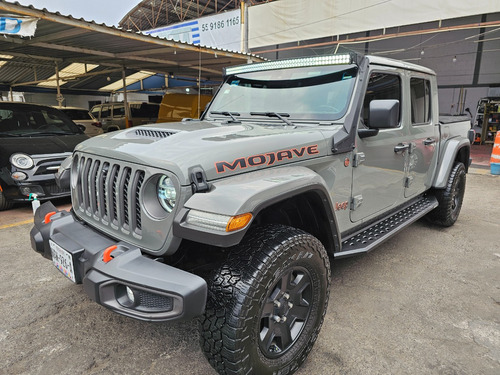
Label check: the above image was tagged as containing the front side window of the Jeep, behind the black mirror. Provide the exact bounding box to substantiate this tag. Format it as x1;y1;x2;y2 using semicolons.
362;72;402;126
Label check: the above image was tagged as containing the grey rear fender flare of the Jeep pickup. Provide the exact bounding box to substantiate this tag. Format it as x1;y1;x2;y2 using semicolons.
432;138;470;189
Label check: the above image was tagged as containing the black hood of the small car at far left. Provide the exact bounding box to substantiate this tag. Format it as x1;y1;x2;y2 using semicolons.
0;134;89;165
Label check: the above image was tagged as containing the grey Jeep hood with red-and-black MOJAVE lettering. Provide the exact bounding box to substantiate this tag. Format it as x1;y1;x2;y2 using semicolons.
76;121;340;185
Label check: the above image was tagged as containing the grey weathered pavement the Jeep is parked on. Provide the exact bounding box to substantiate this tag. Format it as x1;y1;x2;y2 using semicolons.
0;174;500;375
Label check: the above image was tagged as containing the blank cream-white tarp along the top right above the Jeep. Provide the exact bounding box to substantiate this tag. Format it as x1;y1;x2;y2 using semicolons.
248;0;500;49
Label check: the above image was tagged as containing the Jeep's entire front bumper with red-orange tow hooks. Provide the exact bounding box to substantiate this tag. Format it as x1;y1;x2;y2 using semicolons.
30;202;207;321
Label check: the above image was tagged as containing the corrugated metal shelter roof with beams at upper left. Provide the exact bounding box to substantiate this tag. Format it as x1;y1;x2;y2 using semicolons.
0;0;263;90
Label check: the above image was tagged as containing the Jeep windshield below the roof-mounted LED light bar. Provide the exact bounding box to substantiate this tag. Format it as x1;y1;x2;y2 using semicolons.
207;65;357;121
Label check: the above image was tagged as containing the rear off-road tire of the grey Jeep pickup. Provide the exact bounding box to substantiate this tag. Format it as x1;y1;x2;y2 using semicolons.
427;163;466;227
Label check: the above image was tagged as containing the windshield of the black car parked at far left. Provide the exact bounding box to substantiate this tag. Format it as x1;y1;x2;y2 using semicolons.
0;103;80;137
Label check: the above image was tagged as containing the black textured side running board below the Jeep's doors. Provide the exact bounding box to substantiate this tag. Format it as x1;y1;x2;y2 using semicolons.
334;196;438;258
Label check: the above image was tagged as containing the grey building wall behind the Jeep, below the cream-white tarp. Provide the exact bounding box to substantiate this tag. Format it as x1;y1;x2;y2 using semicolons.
252;11;500;115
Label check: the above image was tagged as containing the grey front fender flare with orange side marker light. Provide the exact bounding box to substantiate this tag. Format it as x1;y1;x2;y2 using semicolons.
173;166;340;248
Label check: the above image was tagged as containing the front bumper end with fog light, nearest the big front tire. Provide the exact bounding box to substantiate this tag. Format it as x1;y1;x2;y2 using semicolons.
83;249;207;322
